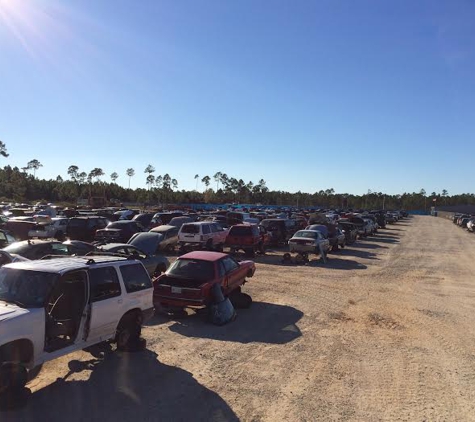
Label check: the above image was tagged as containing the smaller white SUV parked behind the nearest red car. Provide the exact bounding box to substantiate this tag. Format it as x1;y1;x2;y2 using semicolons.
178;221;228;251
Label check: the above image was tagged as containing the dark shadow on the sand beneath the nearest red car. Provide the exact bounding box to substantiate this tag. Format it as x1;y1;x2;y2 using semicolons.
169;302;303;344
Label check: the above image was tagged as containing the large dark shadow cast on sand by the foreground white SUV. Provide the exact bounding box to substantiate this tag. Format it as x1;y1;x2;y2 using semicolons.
2;350;239;422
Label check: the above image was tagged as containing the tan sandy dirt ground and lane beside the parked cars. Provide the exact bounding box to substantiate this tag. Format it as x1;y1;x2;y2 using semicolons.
0;217;475;422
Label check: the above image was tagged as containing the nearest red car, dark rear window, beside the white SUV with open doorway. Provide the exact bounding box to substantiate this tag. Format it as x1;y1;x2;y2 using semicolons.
153;251;256;311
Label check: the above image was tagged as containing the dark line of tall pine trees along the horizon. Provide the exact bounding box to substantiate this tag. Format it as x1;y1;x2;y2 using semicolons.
0;141;475;210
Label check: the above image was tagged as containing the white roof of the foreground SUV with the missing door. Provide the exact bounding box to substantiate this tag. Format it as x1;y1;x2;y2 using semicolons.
4;256;127;274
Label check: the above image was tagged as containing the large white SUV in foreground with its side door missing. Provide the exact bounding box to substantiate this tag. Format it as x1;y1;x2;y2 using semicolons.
0;256;153;393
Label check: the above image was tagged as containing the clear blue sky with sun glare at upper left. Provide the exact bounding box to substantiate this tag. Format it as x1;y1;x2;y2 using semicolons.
0;0;475;194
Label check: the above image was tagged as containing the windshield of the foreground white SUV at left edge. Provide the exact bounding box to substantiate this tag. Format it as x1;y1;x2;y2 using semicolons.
0;267;58;308
